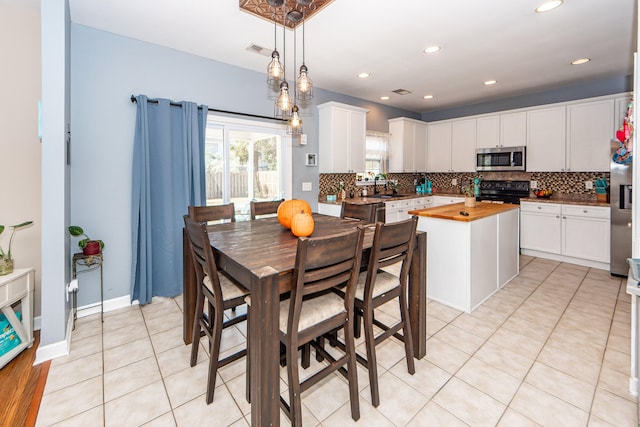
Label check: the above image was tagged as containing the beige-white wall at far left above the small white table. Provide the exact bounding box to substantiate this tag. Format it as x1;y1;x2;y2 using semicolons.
0;0;42;316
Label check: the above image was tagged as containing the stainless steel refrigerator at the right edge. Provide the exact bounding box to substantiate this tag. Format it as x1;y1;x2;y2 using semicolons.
609;139;632;276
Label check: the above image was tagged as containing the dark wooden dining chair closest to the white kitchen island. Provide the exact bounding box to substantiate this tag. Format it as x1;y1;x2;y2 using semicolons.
332;216;418;407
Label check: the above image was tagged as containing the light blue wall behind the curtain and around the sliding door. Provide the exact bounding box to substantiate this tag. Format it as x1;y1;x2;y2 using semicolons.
71;24;420;306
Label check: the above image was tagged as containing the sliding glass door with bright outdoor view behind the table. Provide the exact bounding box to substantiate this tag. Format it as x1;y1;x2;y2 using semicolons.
205;114;291;221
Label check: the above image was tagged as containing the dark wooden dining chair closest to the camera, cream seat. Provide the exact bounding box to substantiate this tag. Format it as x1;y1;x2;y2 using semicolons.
279;227;364;426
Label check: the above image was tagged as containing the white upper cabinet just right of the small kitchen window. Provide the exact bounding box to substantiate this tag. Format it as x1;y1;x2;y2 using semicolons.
389;117;427;172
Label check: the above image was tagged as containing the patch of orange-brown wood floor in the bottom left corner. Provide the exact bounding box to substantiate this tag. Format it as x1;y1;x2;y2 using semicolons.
0;331;51;427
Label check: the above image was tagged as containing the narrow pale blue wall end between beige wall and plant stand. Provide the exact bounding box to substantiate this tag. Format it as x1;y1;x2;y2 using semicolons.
38;0;70;348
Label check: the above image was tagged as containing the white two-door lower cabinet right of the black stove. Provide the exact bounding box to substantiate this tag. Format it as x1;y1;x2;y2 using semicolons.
520;202;610;269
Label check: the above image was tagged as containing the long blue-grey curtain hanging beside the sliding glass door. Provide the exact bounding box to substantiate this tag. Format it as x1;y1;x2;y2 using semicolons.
131;95;208;304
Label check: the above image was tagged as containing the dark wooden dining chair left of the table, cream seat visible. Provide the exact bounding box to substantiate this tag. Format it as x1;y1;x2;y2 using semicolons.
184;215;248;404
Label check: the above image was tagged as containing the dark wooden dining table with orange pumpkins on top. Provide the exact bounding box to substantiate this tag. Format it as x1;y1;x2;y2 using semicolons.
183;213;427;427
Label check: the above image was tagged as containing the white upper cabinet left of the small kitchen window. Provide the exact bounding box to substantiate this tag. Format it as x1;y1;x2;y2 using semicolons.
318;102;368;173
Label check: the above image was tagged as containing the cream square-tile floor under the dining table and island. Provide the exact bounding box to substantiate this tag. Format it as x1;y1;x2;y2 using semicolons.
37;256;637;427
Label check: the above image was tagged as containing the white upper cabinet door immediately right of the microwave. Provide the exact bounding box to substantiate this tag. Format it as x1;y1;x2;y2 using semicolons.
526;106;566;172
